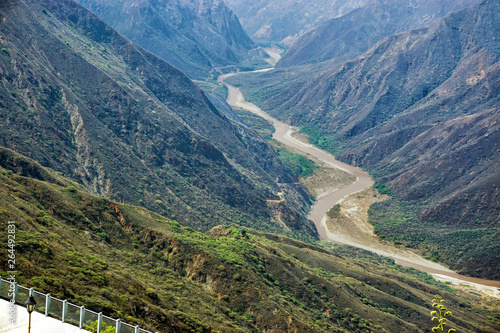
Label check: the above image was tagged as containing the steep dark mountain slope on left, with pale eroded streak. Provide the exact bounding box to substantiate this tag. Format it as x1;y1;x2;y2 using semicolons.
0;0;316;237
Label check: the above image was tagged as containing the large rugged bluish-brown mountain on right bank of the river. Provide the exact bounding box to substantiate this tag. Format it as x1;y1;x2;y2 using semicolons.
227;1;500;279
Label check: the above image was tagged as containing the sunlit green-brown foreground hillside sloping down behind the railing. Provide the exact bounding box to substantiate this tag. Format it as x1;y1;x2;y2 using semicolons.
0;148;499;333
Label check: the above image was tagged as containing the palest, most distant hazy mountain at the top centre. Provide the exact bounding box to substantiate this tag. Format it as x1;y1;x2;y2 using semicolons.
226;0;370;44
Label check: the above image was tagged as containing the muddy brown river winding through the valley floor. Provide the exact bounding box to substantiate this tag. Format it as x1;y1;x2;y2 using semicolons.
218;68;500;298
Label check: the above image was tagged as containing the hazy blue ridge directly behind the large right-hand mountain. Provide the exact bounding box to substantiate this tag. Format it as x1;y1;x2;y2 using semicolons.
277;0;481;67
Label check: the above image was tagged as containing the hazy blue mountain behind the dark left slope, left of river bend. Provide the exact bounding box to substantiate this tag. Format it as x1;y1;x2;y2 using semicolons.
73;0;267;79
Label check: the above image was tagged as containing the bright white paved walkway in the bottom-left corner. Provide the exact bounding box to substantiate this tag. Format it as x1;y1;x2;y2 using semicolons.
0;299;89;333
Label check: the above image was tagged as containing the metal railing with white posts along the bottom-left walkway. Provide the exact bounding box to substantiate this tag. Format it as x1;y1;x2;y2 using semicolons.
0;278;158;333
